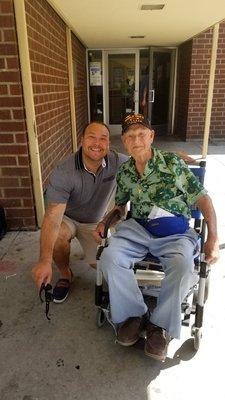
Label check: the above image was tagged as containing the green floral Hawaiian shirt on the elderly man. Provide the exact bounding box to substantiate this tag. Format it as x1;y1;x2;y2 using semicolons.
115;148;207;218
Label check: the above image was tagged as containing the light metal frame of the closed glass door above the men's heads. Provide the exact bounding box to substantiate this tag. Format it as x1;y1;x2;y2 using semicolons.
102;49;140;135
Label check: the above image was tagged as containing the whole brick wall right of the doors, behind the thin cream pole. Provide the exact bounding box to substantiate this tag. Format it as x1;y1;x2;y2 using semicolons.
175;22;225;140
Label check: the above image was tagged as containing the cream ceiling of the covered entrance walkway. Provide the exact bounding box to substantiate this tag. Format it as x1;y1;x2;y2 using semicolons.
49;0;225;48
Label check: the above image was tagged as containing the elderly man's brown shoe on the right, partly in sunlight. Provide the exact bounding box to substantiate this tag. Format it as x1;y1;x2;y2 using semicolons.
145;322;168;361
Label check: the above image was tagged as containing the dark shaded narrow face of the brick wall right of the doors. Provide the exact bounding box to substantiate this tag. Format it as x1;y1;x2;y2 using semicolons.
174;40;192;139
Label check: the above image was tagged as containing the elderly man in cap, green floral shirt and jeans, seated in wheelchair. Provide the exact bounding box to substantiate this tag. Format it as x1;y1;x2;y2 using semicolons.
94;114;219;361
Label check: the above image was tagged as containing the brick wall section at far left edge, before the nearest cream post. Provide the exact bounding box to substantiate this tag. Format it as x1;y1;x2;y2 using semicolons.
0;0;36;229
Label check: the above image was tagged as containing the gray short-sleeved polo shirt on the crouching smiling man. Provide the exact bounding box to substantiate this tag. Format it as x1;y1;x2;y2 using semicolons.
47;149;128;223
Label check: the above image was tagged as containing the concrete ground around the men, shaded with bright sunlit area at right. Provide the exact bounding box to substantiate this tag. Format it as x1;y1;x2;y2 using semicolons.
0;138;225;400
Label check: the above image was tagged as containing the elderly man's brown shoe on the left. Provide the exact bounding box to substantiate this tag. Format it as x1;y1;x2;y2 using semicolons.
116;315;146;346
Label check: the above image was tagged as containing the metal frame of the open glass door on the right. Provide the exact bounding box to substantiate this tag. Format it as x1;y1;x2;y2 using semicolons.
148;46;177;135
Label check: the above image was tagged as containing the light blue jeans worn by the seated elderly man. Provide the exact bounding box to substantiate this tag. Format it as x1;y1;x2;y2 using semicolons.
100;218;198;338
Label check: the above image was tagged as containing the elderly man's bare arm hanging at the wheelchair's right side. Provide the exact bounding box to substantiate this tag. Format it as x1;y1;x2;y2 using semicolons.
196;194;219;264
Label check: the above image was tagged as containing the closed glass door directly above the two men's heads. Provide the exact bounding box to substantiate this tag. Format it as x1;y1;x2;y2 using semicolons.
105;50;139;134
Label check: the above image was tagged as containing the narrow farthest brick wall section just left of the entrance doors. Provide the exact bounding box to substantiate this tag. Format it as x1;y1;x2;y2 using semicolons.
72;34;88;144
